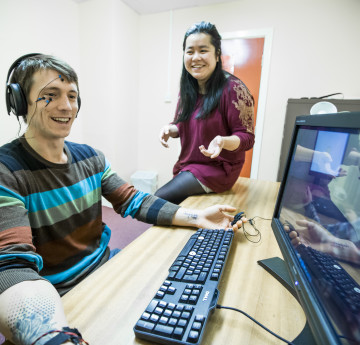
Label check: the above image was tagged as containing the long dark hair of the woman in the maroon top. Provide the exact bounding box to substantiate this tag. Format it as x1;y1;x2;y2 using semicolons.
175;21;226;123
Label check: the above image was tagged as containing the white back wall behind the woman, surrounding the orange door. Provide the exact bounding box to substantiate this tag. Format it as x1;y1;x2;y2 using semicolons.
138;0;360;185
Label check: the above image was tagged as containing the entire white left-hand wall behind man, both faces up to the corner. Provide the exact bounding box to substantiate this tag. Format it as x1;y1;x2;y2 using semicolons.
0;0;139;180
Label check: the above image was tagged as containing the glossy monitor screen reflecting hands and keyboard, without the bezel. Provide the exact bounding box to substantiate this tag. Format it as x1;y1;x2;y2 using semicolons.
277;126;360;344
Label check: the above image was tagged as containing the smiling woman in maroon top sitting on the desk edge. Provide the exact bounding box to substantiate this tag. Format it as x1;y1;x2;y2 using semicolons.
155;22;255;204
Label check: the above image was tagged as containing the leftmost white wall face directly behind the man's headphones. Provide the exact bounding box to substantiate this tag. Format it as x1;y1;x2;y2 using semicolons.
0;0;82;145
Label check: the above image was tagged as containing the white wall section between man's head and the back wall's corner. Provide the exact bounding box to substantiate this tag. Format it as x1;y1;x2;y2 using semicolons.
79;0;141;181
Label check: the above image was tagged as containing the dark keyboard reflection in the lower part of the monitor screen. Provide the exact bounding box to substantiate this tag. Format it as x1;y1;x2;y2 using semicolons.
296;245;360;332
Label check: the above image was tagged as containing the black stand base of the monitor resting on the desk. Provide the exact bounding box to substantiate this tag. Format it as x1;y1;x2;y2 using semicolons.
258;257;316;345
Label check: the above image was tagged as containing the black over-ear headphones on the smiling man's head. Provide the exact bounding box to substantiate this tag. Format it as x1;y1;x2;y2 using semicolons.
5;53;81;116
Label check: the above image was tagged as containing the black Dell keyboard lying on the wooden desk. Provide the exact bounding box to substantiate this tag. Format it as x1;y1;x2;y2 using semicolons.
134;229;234;344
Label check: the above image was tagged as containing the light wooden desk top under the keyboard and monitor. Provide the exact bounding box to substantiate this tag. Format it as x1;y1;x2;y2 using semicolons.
62;178;305;345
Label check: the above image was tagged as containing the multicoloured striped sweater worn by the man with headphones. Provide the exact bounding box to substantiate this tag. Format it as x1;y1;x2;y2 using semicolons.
0;137;179;293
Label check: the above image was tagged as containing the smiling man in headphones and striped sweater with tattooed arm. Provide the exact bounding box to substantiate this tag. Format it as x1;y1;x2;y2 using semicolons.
0;54;241;345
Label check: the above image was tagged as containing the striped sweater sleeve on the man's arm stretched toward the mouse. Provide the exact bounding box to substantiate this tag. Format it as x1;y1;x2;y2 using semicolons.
100;153;180;225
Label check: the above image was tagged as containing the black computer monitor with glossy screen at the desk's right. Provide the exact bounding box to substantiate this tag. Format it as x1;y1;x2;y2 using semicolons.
272;112;360;345
